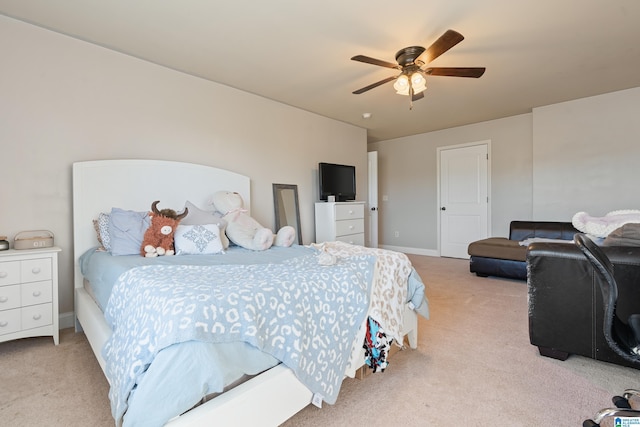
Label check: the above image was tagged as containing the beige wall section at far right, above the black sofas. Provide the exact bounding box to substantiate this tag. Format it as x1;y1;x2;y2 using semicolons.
533;88;640;220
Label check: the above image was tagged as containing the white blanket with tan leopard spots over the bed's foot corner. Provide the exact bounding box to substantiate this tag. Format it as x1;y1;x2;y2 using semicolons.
311;242;412;343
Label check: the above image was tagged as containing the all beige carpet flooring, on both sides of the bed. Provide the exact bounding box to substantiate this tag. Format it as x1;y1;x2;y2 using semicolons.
0;256;640;427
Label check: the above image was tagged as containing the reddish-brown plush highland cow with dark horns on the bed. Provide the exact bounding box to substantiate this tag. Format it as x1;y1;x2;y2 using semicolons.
140;200;189;257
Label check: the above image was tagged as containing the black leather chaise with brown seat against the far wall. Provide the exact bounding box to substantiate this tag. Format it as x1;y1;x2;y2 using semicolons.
467;221;578;280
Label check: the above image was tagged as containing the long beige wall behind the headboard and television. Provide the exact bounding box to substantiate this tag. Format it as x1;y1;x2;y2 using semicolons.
0;16;367;324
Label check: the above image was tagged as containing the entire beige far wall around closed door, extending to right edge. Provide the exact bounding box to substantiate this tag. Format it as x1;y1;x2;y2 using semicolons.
368;88;640;255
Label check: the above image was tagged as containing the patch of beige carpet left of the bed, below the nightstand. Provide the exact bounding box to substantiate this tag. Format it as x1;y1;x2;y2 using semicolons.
0;329;114;427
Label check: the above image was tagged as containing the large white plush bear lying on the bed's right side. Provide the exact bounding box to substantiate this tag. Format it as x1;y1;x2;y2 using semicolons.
213;191;296;251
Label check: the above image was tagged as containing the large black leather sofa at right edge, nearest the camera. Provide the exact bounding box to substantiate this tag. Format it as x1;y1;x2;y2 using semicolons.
527;242;640;369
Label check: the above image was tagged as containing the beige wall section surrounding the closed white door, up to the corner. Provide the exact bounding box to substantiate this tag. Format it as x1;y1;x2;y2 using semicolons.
368;114;532;255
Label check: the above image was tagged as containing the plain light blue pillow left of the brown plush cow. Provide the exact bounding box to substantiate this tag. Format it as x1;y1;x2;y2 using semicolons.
109;208;151;255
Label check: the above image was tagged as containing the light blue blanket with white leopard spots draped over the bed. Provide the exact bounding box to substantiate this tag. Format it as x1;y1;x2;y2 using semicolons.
103;254;375;423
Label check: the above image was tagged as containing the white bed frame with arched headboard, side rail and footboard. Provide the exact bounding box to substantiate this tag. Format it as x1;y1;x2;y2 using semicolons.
73;160;417;427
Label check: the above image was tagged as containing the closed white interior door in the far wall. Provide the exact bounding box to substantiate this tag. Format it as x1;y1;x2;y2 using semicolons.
439;144;489;258
